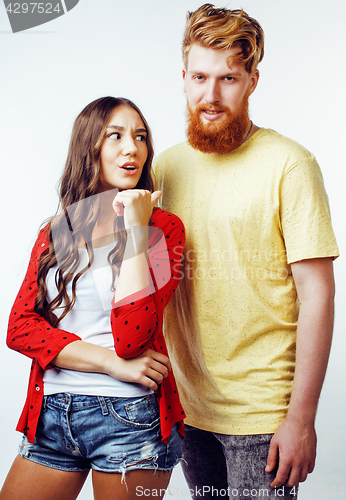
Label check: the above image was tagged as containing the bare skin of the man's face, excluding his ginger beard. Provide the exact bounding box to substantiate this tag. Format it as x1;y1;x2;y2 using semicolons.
183;44;259;126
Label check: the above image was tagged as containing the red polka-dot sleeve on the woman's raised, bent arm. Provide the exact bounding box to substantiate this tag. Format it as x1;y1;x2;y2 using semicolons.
111;209;185;358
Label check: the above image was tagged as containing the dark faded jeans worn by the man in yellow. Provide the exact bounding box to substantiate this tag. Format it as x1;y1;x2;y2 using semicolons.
182;425;298;500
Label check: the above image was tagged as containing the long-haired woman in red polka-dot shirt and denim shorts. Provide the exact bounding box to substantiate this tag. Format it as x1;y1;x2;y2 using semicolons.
0;97;185;500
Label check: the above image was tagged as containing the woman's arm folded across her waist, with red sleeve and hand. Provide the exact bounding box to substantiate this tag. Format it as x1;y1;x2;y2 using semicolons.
7;228;170;389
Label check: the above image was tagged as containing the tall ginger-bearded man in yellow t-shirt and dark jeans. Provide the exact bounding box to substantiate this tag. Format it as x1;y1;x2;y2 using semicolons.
156;4;338;499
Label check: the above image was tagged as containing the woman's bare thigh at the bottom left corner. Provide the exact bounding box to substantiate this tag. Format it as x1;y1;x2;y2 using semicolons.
0;456;89;500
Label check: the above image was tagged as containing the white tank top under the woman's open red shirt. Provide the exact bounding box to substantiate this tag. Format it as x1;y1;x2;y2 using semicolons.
43;243;153;397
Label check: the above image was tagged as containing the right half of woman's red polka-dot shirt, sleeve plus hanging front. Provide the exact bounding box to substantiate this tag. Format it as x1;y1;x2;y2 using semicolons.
111;209;185;442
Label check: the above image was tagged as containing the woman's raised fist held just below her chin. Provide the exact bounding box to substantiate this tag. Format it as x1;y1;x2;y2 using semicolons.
113;189;162;229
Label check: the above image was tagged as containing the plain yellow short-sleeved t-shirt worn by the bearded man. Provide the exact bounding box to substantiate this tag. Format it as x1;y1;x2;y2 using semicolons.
155;129;338;434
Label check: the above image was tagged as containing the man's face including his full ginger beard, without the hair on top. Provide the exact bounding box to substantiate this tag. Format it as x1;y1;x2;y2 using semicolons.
183;45;259;154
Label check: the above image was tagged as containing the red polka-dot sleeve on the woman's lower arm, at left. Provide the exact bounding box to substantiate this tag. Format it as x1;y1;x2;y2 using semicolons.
7;227;80;370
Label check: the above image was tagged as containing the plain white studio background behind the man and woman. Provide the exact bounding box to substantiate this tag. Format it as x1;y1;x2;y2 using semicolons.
0;0;346;500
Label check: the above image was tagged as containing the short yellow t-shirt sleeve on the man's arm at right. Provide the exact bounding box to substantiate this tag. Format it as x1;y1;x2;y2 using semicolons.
280;157;339;264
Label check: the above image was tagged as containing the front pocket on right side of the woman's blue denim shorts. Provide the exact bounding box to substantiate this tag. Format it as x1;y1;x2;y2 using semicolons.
110;394;160;429
